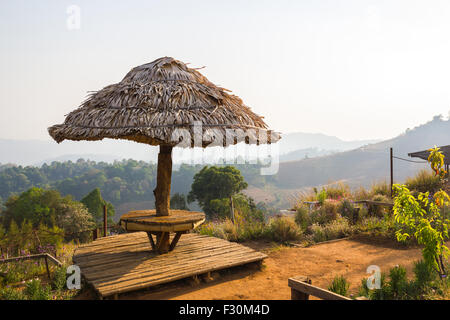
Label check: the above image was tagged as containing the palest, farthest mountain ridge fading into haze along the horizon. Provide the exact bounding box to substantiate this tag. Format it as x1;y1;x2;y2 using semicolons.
0;132;376;166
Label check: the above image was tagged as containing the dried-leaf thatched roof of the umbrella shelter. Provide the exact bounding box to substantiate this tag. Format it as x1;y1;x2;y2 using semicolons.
48;57;280;147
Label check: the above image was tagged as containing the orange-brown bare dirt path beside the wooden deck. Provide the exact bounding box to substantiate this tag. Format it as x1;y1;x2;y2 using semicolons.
115;237;446;300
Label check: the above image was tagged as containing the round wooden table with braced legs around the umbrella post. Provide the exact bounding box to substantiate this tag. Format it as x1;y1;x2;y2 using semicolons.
119;209;205;254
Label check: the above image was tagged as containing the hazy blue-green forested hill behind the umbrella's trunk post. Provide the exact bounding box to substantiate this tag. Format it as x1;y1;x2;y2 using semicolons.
0;159;266;210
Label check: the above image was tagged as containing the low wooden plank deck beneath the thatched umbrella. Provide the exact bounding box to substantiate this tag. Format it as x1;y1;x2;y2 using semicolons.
73;232;267;297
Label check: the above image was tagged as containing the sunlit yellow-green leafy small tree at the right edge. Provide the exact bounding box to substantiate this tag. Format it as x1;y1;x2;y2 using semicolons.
393;147;450;278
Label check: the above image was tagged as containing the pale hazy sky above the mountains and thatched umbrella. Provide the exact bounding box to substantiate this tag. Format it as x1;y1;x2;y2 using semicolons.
0;0;450;140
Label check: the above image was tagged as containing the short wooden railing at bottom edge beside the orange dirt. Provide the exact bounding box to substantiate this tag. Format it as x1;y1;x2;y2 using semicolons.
288;276;352;300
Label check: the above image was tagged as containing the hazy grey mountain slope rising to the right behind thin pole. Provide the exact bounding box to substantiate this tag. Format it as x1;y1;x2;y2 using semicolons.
276;117;450;189
